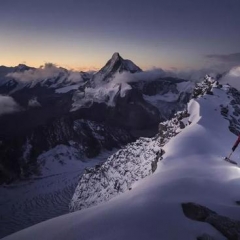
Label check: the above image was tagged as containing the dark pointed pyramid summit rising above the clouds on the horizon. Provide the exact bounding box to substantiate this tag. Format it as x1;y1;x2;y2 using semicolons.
92;52;142;85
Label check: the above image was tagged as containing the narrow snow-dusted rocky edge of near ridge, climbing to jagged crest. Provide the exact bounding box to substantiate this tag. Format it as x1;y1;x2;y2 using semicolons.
70;76;238;211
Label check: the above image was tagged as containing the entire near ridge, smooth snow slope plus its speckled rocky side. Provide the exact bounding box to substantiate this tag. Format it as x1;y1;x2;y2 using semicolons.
4;71;240;240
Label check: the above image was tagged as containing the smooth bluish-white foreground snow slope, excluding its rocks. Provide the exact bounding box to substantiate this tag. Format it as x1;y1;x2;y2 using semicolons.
1;79;240;240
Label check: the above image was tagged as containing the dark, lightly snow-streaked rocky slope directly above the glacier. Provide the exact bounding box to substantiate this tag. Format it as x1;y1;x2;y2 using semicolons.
0;117;134;182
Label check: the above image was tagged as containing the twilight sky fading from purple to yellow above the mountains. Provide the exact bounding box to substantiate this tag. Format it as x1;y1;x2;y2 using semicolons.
0;0;240;70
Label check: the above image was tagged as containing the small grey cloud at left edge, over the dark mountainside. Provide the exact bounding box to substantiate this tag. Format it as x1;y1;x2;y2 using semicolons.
0;95;21;116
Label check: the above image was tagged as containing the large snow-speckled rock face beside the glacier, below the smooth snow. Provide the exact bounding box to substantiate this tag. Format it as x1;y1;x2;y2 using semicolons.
70;138;163;211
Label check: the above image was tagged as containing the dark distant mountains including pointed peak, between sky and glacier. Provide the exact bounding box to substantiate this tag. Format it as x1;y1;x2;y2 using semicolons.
0;53;194;182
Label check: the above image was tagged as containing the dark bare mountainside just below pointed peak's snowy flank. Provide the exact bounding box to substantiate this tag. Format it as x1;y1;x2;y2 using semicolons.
73;86;163;129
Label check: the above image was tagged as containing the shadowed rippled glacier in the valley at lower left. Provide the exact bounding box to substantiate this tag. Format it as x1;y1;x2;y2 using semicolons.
0;145;114;238
